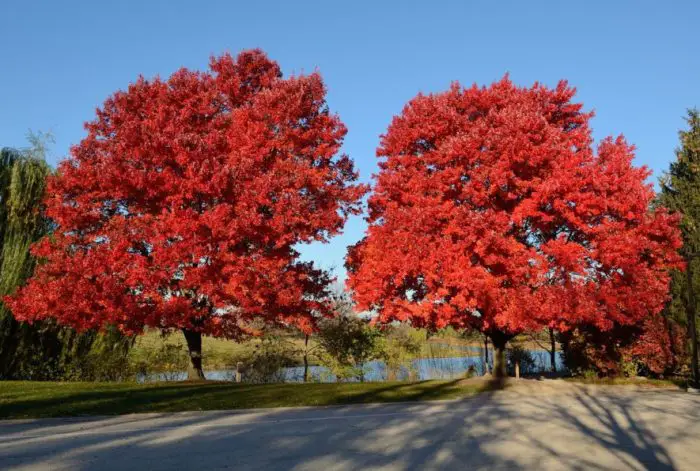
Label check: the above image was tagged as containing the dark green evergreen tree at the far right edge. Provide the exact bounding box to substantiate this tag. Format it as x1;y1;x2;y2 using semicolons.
659;109;700;386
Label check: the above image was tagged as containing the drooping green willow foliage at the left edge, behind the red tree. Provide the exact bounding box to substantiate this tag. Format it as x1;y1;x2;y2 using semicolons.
0;133;131;380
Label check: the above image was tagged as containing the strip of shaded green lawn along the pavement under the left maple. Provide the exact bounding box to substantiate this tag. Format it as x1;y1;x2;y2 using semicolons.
0;380;488;419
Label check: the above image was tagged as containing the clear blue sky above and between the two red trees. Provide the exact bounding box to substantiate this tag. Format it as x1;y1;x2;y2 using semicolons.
0;0;700;276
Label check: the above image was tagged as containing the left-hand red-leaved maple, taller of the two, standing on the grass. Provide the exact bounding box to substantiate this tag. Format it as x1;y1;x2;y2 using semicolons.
7;50;367;378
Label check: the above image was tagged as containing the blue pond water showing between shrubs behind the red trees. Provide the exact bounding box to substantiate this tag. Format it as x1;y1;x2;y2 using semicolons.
139;347;565;383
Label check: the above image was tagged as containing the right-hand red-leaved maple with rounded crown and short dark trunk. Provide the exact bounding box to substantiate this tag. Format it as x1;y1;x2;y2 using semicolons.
346;77;681;375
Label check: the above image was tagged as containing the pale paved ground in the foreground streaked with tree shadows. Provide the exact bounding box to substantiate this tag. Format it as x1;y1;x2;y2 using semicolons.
0;380;700;471
